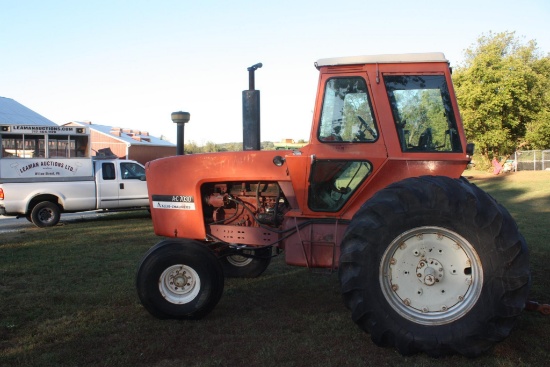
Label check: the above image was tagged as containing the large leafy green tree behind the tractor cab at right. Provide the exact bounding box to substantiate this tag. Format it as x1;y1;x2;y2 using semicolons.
453;32;550;164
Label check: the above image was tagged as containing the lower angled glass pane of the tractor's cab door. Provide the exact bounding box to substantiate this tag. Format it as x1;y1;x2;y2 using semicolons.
308;160;372;212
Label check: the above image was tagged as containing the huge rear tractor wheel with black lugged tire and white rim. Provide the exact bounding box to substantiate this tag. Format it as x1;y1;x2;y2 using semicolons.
339;176;530;356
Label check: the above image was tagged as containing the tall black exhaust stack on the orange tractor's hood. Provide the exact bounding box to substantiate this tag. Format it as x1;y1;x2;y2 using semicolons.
243;63;262;150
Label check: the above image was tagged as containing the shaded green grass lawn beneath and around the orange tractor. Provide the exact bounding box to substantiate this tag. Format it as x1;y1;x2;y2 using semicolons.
0;172;550;367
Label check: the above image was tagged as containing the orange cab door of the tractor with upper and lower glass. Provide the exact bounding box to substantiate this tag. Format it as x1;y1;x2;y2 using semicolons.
307;73;387;215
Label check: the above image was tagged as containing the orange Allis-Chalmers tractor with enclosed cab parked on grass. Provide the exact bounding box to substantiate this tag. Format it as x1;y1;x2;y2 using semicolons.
137;53;530;356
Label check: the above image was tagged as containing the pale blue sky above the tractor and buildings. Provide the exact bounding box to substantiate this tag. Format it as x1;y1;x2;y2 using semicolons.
0;0;550;145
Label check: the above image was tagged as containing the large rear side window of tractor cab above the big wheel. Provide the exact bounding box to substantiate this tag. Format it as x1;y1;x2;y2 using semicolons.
384;75;462;152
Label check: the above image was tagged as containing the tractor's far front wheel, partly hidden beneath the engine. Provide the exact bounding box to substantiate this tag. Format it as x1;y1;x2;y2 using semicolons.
220;247;271;278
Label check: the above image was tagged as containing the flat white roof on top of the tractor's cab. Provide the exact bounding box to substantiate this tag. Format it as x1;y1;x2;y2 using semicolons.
315;52;449;68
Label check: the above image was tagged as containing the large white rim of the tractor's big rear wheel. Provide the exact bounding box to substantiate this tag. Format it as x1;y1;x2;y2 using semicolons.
380;227;483;325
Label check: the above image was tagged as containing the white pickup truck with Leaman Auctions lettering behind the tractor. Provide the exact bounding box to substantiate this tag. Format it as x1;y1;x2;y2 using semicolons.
0;158;149;227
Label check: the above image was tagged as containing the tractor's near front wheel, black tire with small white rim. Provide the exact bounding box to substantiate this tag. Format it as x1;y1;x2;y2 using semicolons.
136;240;224;319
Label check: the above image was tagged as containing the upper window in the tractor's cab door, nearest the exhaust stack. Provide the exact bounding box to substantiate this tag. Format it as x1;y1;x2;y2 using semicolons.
318;77;378;143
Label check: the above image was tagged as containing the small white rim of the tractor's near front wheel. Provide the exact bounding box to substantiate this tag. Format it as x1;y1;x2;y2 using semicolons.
159;264;201;304
